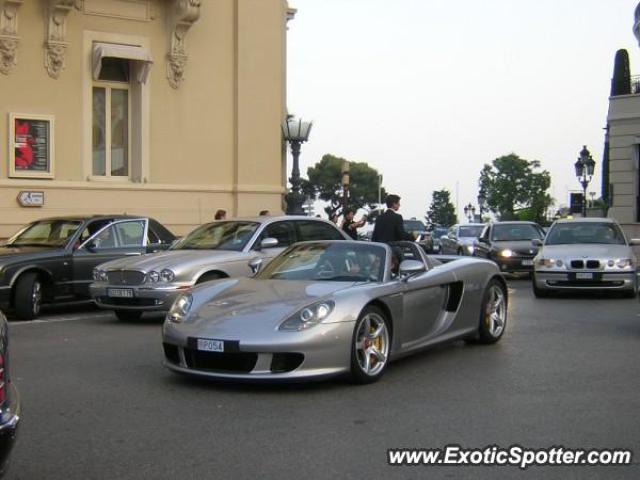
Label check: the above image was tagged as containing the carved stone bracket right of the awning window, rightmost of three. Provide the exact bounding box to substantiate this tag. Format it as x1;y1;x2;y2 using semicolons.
167;0;202;88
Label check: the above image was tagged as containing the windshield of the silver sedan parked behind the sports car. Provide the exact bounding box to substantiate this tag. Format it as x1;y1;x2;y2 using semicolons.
172;222;259;252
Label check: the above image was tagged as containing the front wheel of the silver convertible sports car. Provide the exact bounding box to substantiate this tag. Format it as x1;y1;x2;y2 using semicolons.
351;307;391;383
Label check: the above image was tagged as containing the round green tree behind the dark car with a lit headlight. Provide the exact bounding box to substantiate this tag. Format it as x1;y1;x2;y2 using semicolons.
480;153;553;222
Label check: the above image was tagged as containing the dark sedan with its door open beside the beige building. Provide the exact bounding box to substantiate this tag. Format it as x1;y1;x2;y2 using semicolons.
0;215;175;320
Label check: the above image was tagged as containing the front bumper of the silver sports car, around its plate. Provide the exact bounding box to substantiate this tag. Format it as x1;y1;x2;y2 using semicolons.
163;322;355;382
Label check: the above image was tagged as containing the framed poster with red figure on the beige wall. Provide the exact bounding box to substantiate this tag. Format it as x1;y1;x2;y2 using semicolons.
9;113;54;178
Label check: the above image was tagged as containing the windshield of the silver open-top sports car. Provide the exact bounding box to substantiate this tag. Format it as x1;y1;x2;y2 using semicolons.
257;242;386;282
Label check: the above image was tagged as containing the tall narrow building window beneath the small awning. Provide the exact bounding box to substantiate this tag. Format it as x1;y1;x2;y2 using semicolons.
92;58;131;177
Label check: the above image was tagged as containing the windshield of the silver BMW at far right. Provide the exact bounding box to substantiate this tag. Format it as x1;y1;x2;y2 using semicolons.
545;222;625;245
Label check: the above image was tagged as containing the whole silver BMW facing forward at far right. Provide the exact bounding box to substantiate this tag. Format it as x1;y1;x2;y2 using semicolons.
532;218;640;297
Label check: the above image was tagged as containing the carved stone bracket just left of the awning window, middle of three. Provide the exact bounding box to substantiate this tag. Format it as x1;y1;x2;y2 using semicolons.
44;0;76;78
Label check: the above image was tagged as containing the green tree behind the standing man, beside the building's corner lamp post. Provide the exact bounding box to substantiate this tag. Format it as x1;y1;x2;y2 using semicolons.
303;154;386;217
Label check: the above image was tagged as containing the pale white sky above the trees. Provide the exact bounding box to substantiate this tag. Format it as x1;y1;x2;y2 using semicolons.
287;0;640;219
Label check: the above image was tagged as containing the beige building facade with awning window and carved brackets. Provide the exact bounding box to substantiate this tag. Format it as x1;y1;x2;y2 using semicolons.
0;0;292;238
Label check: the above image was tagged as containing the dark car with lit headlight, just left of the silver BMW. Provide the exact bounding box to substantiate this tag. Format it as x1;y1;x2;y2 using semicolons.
473;221;544;273
